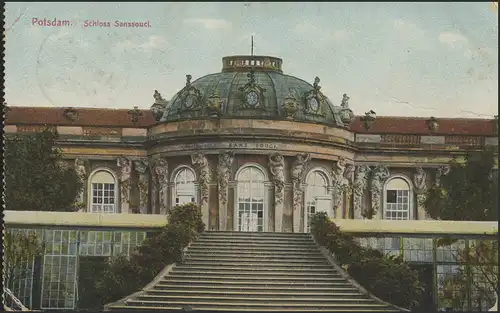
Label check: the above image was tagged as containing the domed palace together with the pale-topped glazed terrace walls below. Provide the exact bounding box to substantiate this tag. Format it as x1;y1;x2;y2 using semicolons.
4;55;498;310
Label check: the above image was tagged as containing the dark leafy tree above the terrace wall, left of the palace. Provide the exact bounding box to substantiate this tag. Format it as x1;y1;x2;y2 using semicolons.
5;129;83;211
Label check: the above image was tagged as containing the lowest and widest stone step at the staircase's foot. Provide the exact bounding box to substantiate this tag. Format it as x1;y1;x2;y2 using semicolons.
110;305;399;313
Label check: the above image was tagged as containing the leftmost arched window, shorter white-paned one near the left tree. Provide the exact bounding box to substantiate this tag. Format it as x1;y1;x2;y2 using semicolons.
89;170;117;213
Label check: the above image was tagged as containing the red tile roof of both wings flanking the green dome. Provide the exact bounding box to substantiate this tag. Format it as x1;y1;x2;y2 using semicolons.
5;107;496;136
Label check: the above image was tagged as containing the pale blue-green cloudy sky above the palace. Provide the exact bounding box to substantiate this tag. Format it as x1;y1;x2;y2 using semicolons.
5;2;498;118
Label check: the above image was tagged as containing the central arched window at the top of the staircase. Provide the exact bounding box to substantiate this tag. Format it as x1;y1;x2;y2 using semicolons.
236;166;265;231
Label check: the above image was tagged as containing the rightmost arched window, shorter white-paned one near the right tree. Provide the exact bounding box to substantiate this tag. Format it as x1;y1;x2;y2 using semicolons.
384;177;412;220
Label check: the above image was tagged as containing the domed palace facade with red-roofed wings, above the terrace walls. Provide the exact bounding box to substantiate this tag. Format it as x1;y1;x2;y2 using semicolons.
5;56;498;232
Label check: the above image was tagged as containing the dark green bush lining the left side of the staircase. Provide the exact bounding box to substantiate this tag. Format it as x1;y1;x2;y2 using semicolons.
85;203;205;309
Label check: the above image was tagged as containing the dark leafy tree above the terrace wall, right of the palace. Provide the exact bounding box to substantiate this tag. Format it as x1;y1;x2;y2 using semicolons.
423;150;498;221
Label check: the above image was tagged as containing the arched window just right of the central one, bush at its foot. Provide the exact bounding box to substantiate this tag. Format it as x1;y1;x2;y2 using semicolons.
304;170;331;232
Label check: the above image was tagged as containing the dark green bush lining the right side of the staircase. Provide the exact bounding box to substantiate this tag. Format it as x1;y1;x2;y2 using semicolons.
311;213;422;309
